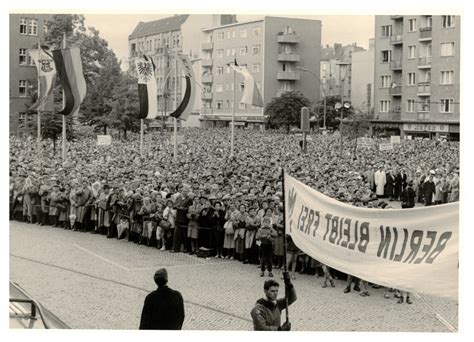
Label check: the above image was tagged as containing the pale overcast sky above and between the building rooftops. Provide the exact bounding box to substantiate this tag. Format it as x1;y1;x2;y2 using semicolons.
85;13;374;65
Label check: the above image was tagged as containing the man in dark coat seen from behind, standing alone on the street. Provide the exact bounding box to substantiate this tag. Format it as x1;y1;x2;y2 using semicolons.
139;268;184;330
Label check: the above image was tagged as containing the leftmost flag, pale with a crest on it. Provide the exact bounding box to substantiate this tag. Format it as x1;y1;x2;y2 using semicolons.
28;45;56;111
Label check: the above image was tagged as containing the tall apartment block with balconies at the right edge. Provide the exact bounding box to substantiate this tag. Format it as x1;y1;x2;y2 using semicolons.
372;15;461;139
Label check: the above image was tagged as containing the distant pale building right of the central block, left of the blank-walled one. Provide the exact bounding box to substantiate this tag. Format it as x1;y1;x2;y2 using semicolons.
320;43;365;102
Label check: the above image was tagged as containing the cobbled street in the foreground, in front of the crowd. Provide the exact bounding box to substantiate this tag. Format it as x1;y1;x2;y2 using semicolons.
10;221;458;332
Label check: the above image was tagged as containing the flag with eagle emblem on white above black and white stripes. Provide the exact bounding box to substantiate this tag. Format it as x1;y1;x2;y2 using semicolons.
135;55;158;119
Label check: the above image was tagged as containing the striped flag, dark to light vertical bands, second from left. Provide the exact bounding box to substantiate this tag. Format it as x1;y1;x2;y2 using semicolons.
53;48;87;115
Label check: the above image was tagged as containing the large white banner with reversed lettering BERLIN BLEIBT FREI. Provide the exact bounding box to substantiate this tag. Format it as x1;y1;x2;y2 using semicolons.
285;174;459;299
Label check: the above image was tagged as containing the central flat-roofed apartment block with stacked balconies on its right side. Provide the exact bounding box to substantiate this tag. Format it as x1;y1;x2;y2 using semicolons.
201;16;321;127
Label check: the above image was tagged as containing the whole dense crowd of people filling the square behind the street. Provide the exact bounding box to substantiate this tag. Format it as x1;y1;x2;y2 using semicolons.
10;129;459;302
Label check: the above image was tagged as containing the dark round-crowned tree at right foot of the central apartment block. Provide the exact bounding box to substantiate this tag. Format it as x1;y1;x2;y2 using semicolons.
265;91;314;133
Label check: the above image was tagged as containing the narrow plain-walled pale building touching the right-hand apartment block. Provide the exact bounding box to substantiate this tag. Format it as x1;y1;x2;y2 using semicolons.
351;39;375;114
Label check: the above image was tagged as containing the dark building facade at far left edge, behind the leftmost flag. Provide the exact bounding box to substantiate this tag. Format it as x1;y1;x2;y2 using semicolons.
9;14;51;134
